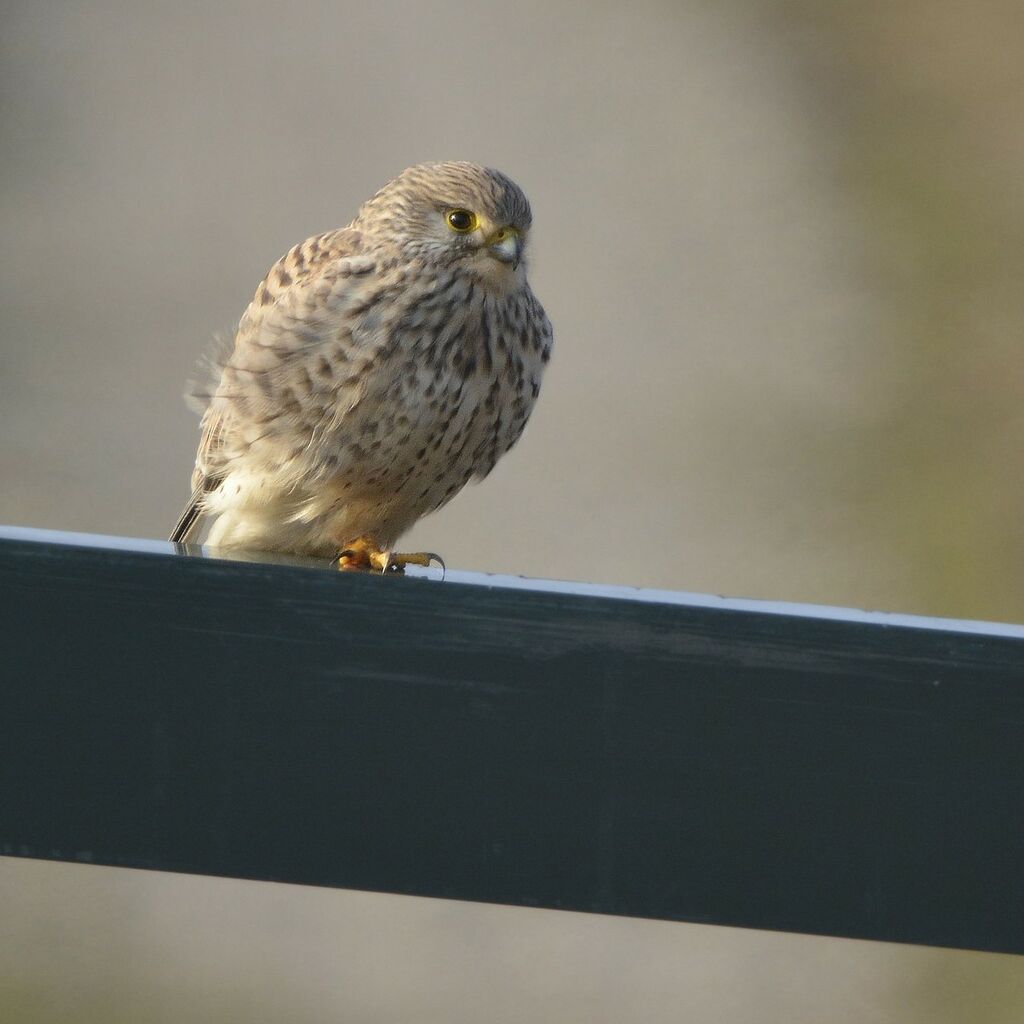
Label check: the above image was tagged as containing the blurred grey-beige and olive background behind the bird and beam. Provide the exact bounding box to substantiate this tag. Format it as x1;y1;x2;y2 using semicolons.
0;0;1024;1024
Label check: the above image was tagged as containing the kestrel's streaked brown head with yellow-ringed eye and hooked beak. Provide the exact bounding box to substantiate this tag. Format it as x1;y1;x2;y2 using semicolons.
352;163;531;290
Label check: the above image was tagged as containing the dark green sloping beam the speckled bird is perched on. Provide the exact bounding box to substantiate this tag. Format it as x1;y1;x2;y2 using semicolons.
0;530;1024;952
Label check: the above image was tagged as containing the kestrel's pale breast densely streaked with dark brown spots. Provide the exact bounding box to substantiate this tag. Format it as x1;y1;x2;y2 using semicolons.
311;290;544;505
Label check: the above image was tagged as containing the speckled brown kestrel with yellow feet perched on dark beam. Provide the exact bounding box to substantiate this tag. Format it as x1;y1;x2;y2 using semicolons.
170;161;553;572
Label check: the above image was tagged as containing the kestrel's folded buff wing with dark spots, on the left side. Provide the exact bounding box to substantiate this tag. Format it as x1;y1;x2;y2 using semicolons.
170;227;375;544
